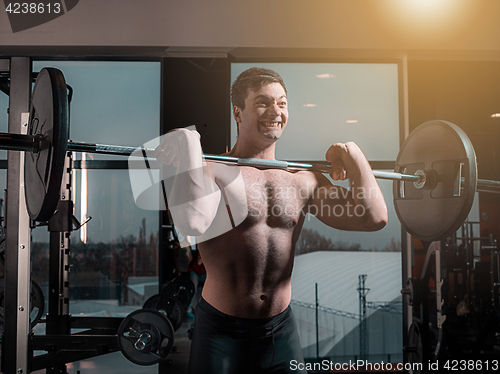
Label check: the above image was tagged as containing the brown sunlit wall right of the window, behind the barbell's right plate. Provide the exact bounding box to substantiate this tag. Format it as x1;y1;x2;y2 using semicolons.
408;61;500;237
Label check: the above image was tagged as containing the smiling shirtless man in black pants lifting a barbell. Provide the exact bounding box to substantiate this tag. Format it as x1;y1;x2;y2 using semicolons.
157;68;387;374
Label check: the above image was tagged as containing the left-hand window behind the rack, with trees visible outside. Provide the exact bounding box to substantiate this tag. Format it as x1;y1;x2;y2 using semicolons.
27;61;161;322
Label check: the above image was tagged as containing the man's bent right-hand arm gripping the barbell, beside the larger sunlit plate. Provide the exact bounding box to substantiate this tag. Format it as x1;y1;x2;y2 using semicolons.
308;142;387;231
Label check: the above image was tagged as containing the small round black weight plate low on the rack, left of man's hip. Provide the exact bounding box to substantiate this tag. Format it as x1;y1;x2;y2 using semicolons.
118;309;174;365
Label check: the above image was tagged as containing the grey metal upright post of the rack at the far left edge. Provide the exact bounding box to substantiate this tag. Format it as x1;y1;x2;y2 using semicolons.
2;57;31;374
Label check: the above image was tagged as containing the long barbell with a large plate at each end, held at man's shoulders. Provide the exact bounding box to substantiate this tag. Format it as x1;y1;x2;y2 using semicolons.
0;68;500;242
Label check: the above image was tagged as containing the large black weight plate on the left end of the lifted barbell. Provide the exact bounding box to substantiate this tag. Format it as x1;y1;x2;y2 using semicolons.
24;68;69;221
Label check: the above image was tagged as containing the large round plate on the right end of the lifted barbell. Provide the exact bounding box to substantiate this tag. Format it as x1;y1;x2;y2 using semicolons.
393;120;477;242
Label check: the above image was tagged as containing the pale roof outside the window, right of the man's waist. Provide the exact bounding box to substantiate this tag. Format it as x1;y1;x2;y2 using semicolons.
292;251;402;362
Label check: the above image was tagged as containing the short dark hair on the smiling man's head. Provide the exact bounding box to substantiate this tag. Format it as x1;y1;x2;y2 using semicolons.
231;68;286;110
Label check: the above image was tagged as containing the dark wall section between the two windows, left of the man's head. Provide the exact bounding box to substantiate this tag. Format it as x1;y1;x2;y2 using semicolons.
162;58;231;154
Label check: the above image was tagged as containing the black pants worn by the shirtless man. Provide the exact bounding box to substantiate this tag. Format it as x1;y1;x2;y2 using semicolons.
189;298;307;374
